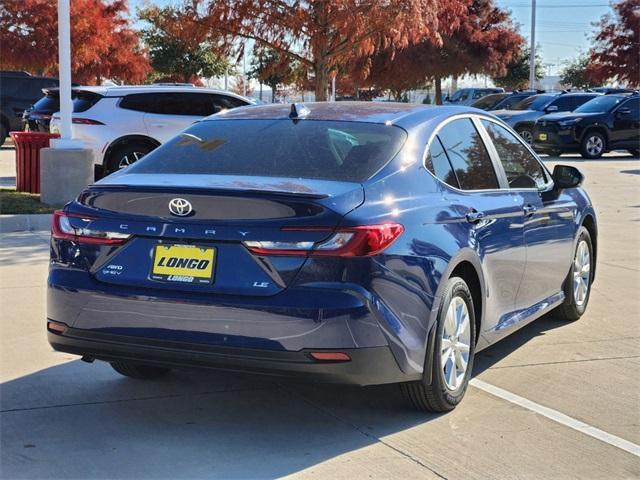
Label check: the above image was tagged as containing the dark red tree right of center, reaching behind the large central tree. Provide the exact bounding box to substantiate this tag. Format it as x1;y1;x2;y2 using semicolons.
360;0;524;104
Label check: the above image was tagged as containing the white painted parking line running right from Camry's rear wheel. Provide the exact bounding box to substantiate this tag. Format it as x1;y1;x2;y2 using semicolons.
469;378;640;457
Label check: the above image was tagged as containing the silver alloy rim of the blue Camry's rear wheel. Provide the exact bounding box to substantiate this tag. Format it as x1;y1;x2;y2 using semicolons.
440;297;471;390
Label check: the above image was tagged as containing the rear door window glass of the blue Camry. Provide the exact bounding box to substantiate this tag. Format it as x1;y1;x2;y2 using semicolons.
438;118;498;190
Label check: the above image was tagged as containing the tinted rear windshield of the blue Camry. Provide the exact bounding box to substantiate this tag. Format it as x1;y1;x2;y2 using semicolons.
128;120;407;182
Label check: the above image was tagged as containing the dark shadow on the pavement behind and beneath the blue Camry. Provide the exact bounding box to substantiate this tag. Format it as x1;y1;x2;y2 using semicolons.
1;360;435;479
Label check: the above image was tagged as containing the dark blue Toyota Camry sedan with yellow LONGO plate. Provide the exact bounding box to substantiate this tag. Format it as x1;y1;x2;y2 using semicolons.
47;102;597;411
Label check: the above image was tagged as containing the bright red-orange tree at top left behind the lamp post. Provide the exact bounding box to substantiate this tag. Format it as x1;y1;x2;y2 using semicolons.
0;0;151;84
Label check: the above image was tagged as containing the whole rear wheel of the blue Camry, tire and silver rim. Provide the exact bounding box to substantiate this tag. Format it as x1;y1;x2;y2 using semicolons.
401;277;476;412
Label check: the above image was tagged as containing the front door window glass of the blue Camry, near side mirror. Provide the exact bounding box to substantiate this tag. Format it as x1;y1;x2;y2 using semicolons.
482;120;547;188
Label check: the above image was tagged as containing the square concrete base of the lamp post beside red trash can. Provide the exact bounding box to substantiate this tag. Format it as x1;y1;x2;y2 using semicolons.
40;148;94;205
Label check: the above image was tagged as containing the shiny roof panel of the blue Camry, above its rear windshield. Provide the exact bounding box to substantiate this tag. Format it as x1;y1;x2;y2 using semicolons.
205;101;484;127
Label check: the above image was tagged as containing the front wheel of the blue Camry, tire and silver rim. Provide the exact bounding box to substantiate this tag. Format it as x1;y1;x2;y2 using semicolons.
554;227;593;321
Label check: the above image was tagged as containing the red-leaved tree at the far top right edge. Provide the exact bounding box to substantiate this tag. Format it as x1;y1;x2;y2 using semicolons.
587;0;640;86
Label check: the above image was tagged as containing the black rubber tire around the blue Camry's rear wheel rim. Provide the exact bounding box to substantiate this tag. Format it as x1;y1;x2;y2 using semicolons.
400;277;476;412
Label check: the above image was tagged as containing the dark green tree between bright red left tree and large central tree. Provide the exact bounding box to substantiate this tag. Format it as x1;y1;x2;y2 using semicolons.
138;6;231;82
